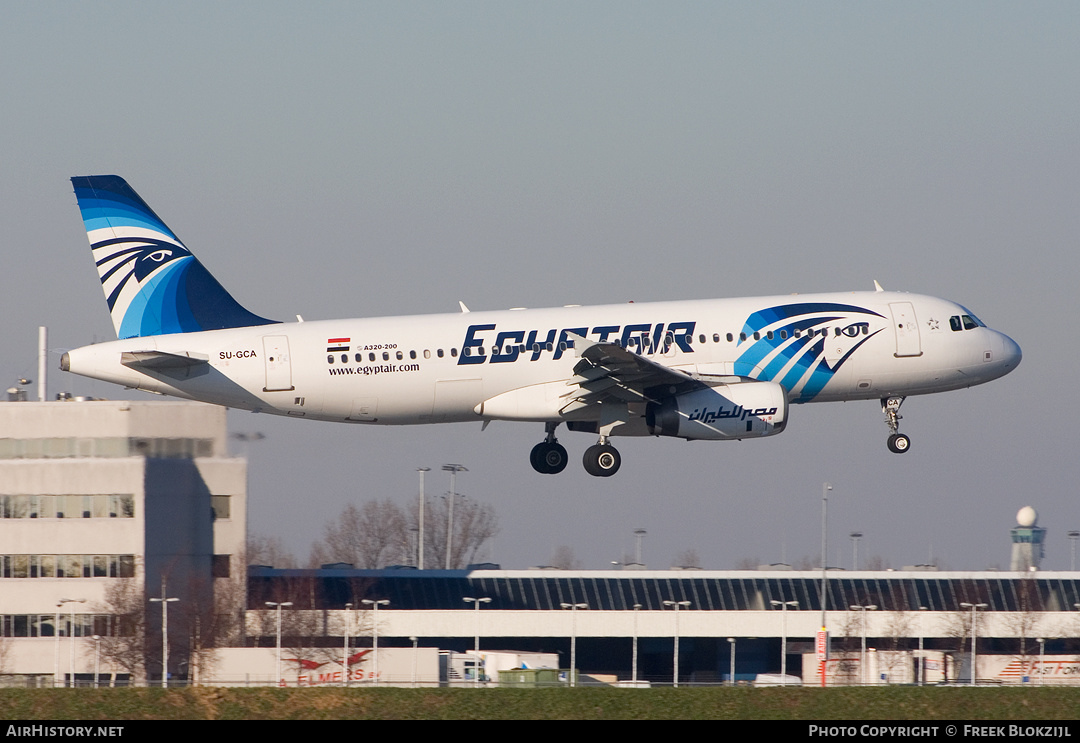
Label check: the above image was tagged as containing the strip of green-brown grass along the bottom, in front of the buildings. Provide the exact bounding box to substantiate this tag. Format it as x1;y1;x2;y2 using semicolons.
0;687;1080;721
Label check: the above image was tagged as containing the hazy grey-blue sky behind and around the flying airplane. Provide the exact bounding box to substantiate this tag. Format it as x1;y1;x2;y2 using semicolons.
0;2;1080;569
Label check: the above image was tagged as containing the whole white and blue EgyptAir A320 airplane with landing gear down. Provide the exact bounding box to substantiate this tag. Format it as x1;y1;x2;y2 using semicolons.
60;175;1022;477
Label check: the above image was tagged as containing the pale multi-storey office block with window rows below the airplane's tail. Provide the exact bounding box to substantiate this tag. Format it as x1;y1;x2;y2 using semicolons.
0;401;246;686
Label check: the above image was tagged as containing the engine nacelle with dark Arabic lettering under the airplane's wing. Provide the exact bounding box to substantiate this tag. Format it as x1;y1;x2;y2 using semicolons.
645;382;787;441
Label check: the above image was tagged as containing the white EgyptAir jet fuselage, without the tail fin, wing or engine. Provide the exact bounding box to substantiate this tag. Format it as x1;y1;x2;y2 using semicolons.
64;292;1021;424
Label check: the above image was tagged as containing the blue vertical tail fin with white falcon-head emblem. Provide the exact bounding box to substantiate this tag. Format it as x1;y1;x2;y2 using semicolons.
71;175;276;338
